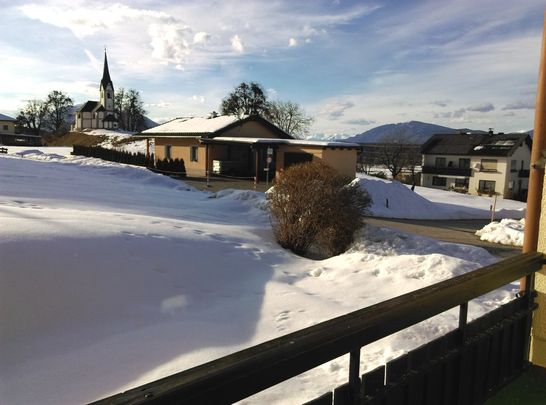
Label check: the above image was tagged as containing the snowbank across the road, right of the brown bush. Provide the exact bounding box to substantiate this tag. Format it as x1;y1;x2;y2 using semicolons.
355;173;525;220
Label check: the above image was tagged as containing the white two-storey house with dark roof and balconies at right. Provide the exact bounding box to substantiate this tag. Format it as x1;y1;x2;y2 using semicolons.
421;132;531;199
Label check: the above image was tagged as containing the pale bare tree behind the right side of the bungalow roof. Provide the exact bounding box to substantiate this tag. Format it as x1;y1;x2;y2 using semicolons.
267;101;313;138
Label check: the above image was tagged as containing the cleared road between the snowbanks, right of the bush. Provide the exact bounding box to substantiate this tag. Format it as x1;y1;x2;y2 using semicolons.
366;217;521;258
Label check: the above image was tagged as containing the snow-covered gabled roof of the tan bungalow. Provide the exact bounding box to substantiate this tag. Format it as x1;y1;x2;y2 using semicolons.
138;115;293;139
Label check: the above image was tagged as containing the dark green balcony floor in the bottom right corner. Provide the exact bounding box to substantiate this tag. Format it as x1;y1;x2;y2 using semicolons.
485;366;546;405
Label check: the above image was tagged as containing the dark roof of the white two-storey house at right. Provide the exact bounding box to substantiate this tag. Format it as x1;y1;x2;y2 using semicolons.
421;133;531;156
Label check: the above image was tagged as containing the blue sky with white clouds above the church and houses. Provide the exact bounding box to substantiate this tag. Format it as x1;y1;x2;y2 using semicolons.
0;0;545;135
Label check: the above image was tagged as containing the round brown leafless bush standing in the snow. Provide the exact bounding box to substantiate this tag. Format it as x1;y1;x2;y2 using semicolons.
267;162;371;256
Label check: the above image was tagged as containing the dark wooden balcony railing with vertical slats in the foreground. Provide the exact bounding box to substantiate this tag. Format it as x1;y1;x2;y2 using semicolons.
91;253;543;405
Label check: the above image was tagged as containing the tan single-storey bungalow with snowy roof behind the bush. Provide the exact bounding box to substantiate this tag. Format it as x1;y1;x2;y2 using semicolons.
136;116;359;182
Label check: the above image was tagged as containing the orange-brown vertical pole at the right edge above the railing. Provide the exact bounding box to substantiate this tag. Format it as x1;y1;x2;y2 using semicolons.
520;13;546;290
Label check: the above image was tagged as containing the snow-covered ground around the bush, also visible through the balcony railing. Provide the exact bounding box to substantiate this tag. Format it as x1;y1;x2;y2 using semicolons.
0;147;523;404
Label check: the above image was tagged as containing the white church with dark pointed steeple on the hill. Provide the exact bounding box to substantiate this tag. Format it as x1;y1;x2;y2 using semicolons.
73;50;118;131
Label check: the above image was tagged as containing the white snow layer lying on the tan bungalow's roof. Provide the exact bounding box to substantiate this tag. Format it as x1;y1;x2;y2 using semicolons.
142;115;239;135
